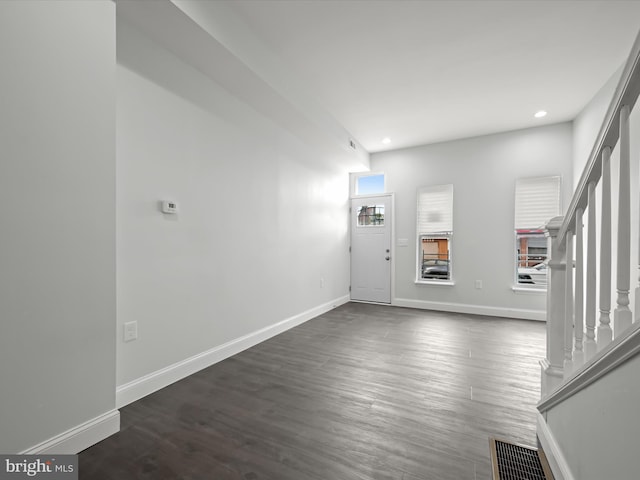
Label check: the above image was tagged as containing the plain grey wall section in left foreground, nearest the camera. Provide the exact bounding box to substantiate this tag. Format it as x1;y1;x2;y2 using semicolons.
0;1;116;454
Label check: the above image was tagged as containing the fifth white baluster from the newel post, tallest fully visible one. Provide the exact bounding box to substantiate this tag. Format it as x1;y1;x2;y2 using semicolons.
613;105;632;337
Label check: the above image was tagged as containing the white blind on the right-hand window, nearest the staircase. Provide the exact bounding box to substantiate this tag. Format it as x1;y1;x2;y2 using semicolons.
515;177;560;230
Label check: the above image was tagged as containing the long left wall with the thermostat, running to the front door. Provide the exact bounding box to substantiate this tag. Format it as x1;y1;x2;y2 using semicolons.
116;20;349;387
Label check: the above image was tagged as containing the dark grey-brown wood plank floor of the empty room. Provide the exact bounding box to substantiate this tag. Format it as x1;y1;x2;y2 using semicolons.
80;303;545;480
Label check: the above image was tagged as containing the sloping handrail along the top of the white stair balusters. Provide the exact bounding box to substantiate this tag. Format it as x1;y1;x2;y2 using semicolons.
558;33;640;244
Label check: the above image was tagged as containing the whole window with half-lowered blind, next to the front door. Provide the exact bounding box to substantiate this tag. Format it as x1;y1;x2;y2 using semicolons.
416;185;453;284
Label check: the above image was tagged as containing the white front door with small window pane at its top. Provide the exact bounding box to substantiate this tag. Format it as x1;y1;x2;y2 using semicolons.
351;195;392;303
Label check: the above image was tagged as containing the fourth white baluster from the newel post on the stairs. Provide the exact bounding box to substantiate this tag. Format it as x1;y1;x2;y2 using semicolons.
598;147;612;350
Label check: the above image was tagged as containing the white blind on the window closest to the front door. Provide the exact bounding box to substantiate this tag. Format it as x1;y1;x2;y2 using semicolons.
417;184;453;235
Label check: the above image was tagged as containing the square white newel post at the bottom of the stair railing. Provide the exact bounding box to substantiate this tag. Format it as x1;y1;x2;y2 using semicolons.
540;217;566;398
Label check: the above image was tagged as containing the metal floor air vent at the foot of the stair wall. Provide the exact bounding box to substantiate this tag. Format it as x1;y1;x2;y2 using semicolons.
489;438;553;480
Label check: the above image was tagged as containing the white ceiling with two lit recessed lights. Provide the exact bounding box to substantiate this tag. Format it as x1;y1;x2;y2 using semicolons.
230;0;640;152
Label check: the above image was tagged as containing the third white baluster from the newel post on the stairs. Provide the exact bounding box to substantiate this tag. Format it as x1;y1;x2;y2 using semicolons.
584;182;598;360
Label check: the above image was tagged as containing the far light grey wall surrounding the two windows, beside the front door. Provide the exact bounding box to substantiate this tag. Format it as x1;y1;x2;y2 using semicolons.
371;123;573;319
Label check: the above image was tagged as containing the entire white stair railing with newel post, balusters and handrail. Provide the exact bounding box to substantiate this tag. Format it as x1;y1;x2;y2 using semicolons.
541;29;640;399
